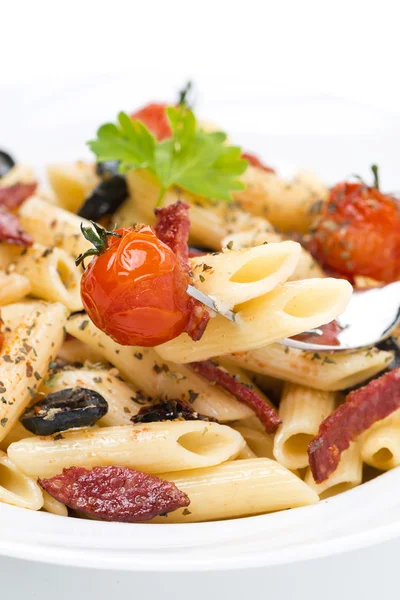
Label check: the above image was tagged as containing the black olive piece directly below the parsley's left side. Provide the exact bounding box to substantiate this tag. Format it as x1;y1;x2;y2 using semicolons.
78;175;128;221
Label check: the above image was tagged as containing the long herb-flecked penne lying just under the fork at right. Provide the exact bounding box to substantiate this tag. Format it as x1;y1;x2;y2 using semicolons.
229;344;393;391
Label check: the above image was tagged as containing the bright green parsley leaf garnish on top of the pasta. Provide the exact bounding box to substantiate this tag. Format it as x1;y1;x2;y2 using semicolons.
89;106;248;203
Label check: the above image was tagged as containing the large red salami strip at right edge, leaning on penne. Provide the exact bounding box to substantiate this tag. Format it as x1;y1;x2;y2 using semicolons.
308;369;400;483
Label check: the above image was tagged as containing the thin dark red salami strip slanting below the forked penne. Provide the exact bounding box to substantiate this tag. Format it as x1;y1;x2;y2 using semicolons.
189;360;281;433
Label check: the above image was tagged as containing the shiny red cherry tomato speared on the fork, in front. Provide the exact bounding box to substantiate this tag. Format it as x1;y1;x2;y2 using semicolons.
81;225;191;346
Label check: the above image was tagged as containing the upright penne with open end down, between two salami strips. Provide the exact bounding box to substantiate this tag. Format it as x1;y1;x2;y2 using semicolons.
274;383;336;469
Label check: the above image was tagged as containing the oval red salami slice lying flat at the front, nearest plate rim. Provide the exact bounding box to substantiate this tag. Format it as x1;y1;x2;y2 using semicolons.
39;466;190;523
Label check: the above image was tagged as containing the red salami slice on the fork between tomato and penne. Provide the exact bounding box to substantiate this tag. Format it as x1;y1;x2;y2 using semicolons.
154;201;210;342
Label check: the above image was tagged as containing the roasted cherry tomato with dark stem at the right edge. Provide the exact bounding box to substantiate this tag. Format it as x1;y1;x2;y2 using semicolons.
310;182;400;283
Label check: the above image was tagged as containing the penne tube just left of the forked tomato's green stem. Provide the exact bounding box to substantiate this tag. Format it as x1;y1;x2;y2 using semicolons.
19;196;90;259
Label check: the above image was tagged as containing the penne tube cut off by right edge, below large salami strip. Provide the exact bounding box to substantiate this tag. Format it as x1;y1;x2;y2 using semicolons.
360;410;400;471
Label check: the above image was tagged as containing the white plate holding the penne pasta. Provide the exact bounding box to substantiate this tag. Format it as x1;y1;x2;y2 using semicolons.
0;75;400;571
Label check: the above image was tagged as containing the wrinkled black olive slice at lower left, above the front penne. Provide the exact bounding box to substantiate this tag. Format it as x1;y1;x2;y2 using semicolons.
20;387;108;435
